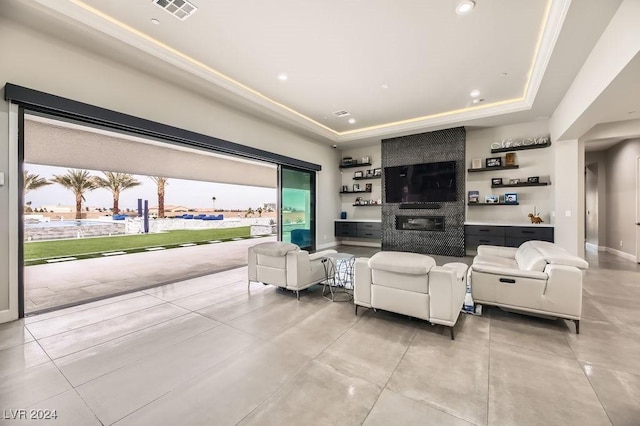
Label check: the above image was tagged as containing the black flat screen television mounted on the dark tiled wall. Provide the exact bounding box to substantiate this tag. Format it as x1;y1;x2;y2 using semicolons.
384;161;457;203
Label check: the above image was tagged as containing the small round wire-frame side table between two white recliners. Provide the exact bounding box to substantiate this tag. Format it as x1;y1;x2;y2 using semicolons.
322;253;356;302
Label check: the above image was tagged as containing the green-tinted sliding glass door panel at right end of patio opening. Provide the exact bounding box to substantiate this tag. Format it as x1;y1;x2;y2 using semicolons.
278;166;316;251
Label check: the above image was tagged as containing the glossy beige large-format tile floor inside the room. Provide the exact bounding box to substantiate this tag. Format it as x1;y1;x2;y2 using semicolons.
0;249;640;425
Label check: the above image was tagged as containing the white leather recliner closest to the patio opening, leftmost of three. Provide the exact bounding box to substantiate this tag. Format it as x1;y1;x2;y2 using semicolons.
247;241;336;299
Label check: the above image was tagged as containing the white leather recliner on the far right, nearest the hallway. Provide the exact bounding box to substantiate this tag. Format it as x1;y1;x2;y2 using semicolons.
469;241;589;333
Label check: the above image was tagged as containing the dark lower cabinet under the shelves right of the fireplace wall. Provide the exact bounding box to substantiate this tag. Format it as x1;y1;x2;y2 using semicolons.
464;225;553;249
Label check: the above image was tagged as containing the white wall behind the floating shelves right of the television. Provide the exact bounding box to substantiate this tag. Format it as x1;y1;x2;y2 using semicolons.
465;120;556;224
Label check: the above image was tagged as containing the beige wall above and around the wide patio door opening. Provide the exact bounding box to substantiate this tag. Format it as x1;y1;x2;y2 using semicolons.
0;18;341;317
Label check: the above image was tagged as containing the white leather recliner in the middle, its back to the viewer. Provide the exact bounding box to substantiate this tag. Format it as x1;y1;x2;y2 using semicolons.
353;251;468;340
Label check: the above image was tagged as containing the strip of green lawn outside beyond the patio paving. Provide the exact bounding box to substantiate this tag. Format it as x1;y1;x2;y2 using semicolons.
24;226;251;265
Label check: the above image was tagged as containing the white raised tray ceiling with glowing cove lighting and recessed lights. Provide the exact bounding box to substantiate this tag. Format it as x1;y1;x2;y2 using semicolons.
2;0;632;145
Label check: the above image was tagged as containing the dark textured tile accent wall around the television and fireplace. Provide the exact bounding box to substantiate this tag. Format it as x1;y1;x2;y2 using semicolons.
382;127;466;257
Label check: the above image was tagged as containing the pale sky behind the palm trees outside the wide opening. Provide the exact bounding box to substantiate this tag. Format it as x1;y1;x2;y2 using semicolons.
24;163;277;210
